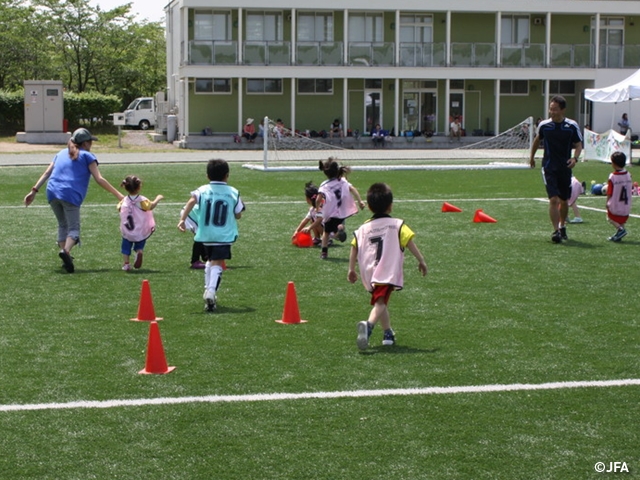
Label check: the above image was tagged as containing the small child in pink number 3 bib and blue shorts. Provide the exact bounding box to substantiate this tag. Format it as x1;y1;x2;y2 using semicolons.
118;175;164;272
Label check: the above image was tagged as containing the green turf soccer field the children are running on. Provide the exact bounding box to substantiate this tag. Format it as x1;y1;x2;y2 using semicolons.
0;162;640;480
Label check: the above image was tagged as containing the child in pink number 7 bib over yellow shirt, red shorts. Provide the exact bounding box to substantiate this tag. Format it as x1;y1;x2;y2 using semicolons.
347;183;427;350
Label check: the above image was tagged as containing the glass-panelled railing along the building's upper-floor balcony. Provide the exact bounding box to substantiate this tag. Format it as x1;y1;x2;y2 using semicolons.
188;40;640;68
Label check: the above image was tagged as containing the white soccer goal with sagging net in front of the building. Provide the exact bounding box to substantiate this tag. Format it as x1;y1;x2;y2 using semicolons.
243;117;535;171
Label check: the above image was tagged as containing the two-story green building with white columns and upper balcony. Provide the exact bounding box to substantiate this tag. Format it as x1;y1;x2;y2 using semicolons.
165;0;640;143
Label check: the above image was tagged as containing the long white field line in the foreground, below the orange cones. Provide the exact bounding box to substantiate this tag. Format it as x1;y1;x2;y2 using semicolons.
0;379;640;412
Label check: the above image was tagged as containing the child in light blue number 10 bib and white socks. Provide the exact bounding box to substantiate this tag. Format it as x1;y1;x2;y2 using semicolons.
178;159;245;312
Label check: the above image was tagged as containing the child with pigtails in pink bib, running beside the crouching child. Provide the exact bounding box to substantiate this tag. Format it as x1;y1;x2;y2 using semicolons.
302;157;364;260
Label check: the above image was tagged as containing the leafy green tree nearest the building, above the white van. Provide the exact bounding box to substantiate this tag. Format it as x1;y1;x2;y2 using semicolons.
32;0;166;99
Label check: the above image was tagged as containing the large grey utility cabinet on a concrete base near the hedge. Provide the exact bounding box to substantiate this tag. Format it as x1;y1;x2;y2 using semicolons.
16;80;71;144
